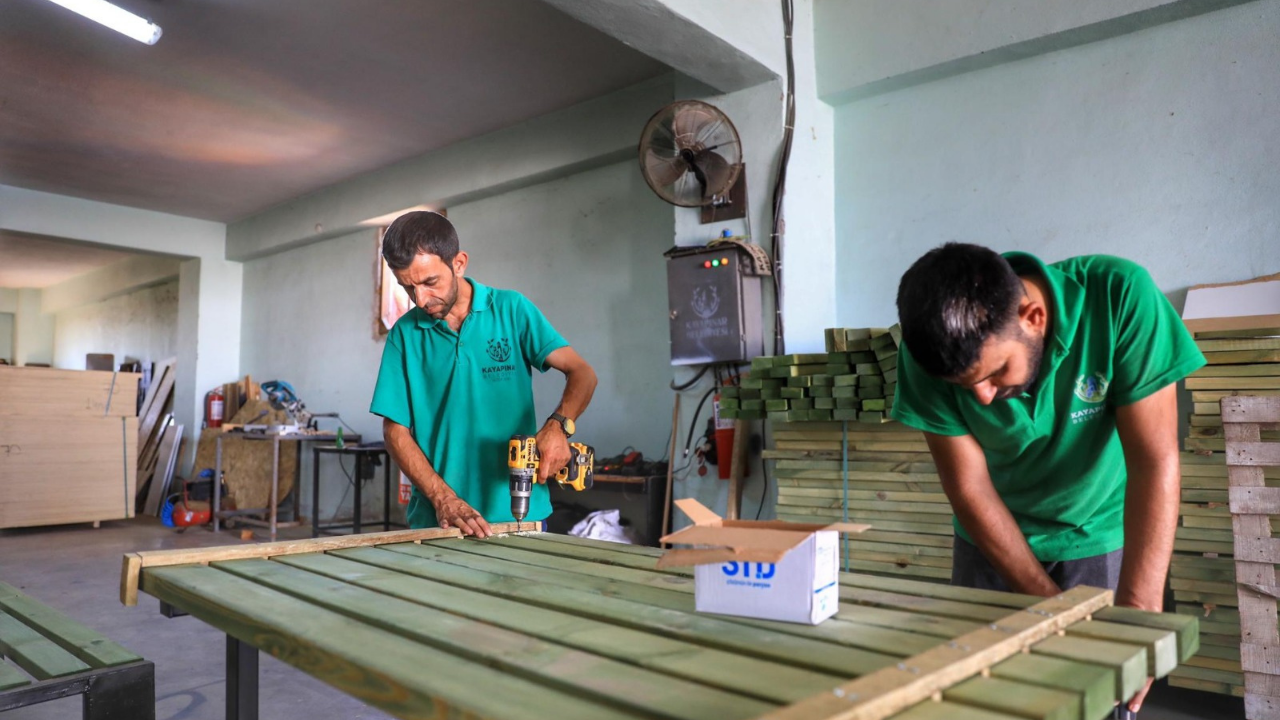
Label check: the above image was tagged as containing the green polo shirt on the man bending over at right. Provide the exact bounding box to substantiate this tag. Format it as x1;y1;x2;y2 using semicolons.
893;252;1204;561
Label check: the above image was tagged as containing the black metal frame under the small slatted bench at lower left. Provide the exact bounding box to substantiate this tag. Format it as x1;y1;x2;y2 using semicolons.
0;661;156;720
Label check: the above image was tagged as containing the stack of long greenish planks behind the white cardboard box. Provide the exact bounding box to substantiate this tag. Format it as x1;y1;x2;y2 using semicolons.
764;423;952;582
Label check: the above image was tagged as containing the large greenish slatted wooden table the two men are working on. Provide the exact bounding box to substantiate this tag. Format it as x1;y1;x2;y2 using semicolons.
120;524;1199;720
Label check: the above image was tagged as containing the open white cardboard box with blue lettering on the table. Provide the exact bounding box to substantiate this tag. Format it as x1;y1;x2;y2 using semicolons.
658;500;870;625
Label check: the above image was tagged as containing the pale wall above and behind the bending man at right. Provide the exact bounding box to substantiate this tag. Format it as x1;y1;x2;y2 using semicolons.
836;0;1280;325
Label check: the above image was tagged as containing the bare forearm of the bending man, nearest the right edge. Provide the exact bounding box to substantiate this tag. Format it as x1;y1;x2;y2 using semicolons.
1116;455;1181;612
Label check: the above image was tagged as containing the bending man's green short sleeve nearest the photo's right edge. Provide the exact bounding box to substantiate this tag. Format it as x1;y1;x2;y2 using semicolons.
1110;264;1204;405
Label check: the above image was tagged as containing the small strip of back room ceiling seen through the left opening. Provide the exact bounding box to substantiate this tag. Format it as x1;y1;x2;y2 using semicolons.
0;232;133;287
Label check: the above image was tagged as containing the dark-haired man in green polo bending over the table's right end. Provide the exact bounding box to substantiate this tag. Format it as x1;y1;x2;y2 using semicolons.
893;243;1204;712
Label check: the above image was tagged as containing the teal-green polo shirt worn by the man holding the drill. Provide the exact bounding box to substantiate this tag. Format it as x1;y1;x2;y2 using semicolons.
369;279;568;528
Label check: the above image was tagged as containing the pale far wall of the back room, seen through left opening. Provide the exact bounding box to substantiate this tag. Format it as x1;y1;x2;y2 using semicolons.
54;281;178;370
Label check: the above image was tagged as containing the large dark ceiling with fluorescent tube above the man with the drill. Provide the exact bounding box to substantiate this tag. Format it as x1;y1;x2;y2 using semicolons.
0;0;667;221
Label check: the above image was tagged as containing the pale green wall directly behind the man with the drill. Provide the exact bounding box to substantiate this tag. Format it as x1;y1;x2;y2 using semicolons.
241;163;671;518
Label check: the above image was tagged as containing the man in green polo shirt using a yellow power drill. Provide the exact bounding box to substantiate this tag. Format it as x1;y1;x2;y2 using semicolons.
370;211;595;537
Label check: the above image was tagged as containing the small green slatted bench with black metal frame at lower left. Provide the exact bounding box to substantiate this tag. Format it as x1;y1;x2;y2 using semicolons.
0;583;156;720
